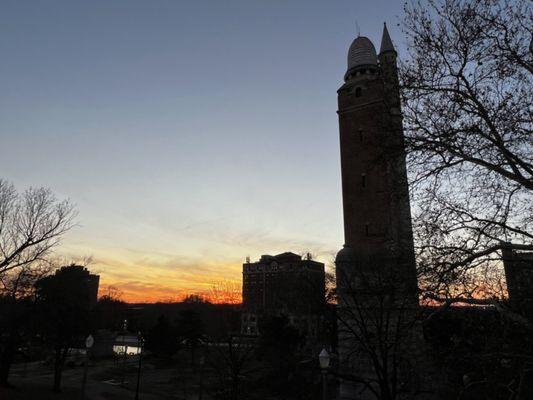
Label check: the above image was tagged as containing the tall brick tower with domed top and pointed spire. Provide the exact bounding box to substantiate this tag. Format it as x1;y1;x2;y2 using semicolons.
335;26;418;400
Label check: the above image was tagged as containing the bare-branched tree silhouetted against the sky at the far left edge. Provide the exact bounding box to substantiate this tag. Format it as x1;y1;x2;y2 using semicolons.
0;179;76;385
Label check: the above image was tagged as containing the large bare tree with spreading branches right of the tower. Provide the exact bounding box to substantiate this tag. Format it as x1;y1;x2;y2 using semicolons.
400;0;533;301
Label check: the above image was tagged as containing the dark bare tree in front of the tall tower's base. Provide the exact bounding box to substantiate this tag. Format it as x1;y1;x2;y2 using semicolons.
335;255;422;400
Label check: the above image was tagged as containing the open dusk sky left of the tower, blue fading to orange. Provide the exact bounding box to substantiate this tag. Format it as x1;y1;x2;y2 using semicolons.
0;0;405;301
